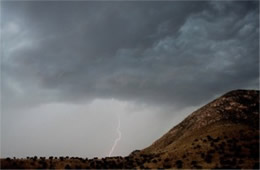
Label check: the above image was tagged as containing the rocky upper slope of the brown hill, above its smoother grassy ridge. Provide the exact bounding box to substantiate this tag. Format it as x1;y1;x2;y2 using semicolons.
143;90;259;151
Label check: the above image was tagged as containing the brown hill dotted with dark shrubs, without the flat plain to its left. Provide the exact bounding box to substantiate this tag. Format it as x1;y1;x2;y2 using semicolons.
137;90;259;168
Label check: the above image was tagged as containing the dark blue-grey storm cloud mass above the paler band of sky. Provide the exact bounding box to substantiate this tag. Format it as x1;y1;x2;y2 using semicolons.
2;1;259;110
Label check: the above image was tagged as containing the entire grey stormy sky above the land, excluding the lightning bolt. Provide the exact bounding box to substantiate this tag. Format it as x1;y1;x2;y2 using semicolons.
1;1;259;157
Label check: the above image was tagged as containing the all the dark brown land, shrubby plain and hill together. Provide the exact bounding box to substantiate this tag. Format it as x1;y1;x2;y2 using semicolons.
1;90;259;169
